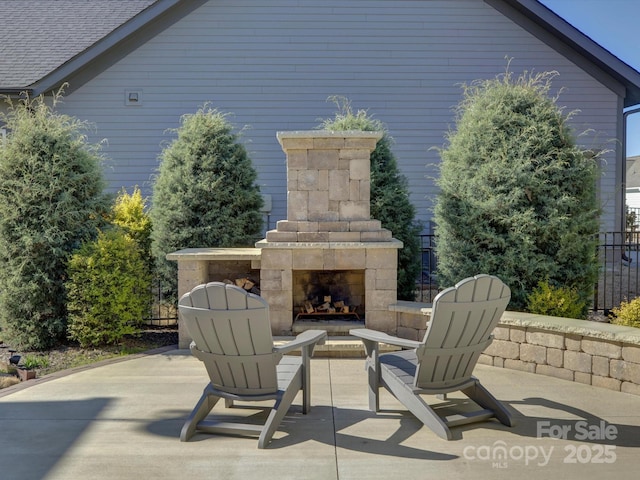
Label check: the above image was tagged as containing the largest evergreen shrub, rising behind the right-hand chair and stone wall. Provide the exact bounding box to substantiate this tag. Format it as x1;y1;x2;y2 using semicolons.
434;68;599;317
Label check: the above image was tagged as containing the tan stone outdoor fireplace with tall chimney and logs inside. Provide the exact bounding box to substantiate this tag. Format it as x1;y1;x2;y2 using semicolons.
256;131;402;335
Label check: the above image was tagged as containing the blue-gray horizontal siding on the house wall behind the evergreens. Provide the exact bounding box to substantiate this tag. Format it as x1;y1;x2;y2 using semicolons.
46;0;617;232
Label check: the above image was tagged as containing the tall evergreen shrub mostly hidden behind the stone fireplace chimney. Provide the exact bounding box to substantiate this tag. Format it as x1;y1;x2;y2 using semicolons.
320;97;421;300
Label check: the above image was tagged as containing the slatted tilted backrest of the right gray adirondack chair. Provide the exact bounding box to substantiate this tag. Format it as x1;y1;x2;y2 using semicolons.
414;275;511;388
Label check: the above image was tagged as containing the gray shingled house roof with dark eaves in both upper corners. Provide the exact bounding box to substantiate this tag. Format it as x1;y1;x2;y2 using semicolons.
0;0;640;107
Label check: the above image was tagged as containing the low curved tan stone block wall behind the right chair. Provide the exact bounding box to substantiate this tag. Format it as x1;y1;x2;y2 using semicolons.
390;308;640;395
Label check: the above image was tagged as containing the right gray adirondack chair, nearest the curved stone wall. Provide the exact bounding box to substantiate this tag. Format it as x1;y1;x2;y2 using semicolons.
350;275;513;440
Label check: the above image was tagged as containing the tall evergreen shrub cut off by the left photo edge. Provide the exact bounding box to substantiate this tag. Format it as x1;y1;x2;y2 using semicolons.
0;94;108;349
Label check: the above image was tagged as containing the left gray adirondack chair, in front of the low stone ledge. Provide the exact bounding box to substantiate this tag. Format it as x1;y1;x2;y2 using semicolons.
178;282;327;448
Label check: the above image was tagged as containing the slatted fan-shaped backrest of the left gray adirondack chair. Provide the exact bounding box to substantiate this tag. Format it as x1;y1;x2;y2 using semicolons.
180;282;282;395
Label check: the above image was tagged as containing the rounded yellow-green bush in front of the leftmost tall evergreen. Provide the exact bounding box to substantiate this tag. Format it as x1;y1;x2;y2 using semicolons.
67;227;151;347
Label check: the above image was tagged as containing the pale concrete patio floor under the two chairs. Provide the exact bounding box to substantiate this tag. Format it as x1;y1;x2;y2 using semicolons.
0;344;640;480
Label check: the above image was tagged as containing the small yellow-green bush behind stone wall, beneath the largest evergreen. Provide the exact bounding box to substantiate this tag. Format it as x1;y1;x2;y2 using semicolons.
526;281;588;319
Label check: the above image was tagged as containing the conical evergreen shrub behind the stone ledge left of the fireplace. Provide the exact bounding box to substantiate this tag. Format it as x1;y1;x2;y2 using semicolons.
151;106;263;301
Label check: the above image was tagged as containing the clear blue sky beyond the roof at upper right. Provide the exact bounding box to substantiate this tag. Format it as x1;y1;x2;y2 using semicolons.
539;0;640;156
